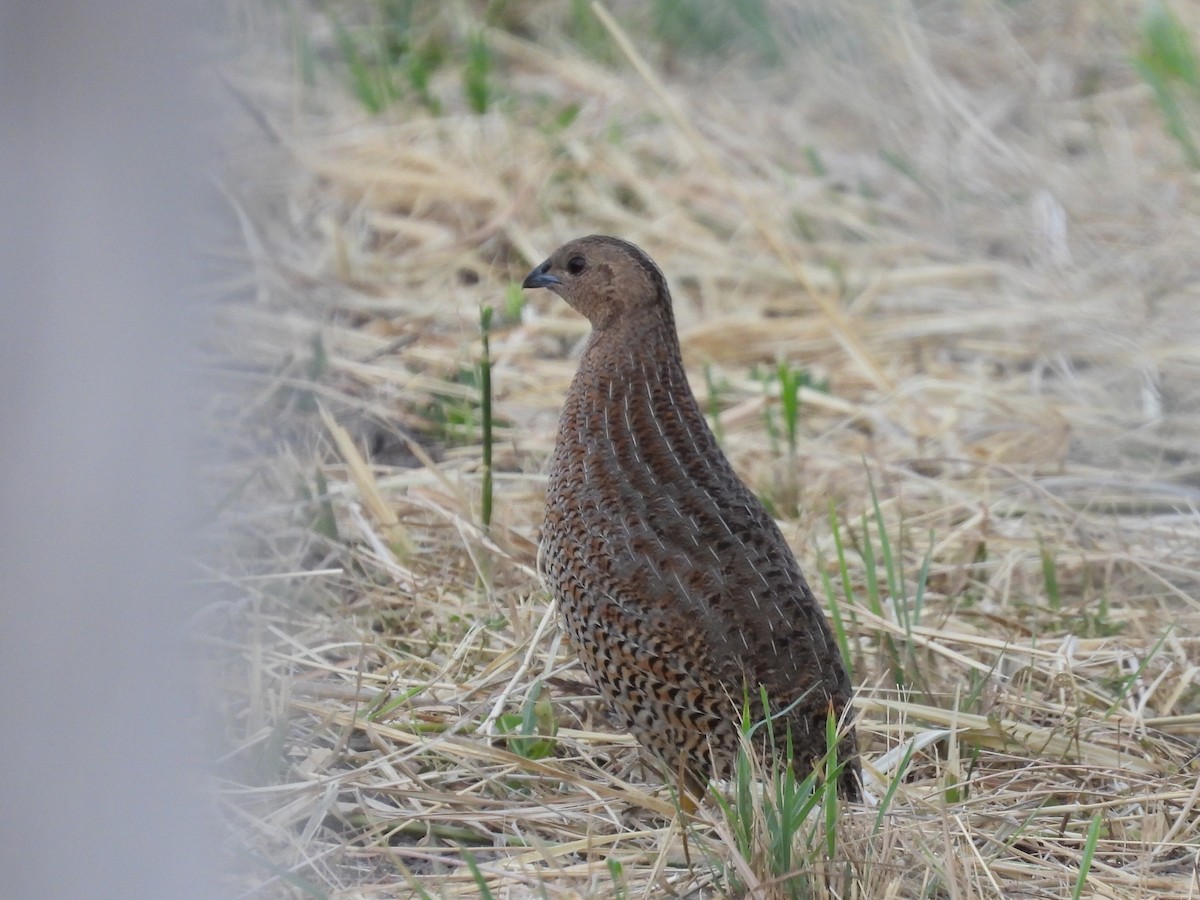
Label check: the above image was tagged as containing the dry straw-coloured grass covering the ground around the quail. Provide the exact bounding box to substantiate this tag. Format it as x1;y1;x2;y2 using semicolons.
202;0;1200;898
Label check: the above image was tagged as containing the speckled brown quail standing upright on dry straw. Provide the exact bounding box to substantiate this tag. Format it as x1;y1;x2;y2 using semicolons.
522;235;859;798
